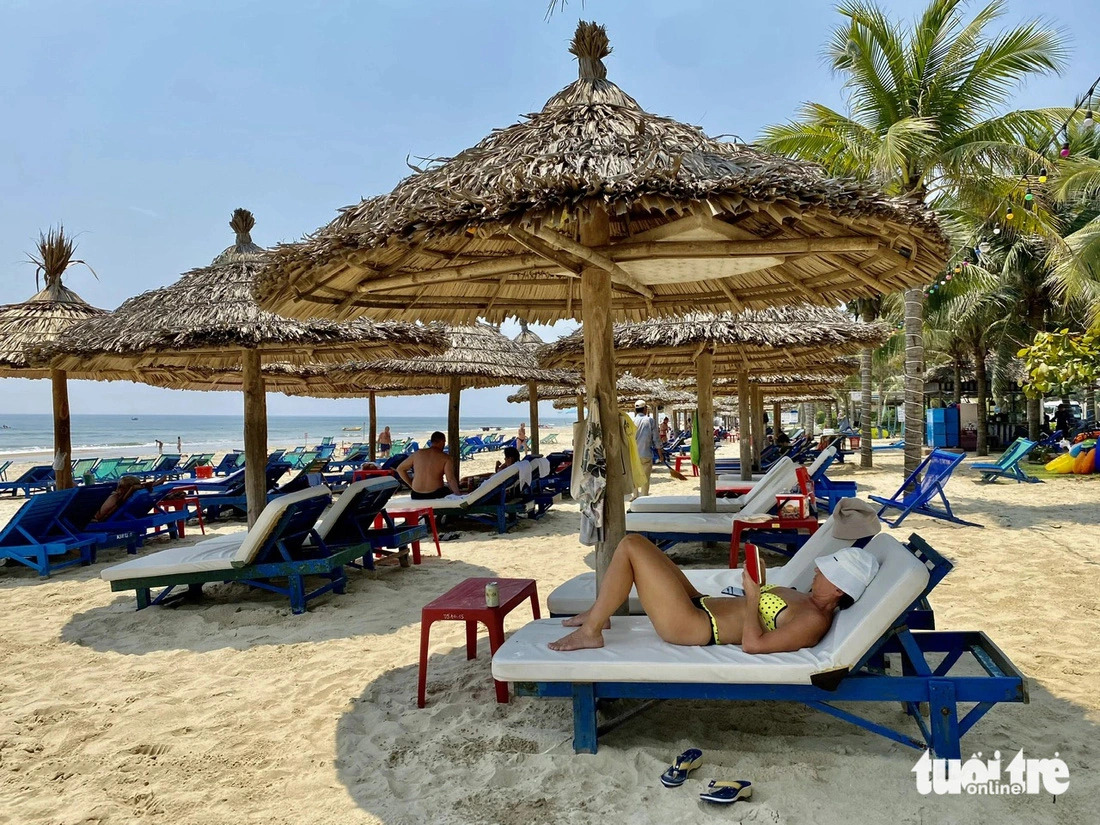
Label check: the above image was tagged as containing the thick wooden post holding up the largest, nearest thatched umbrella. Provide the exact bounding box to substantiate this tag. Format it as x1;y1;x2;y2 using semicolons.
580;204;626;589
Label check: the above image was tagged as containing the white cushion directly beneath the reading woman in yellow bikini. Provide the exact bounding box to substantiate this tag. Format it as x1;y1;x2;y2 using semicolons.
493;534;928;684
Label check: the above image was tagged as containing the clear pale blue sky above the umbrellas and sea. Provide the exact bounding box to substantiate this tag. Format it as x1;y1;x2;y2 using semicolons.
0;0;1100;416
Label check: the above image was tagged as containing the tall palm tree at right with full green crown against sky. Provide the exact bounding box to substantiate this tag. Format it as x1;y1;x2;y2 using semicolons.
761;0;1066;473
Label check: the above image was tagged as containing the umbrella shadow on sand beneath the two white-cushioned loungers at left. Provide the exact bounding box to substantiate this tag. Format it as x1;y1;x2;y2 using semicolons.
61;556;494;655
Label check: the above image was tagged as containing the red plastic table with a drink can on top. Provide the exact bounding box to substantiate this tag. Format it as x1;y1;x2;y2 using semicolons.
416;579;541;707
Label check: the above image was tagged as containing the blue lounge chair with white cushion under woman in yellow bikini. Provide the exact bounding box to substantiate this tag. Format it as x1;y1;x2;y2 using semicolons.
493;534;1029;759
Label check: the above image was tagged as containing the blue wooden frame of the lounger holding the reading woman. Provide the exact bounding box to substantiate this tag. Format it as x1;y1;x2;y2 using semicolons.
503;535;1029;759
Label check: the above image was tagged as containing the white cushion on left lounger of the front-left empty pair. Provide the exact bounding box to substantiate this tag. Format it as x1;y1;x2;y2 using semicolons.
99;486;329;582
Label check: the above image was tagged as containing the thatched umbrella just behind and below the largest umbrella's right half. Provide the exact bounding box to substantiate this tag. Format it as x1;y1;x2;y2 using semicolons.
540;306;892;490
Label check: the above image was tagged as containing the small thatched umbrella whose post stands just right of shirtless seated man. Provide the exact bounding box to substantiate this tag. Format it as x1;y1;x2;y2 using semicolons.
331;323;576;477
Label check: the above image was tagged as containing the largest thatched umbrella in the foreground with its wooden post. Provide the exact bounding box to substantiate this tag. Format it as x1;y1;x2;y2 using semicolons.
249;23;947;573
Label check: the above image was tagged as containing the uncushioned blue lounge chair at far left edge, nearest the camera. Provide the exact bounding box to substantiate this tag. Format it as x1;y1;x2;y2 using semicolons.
0;487;100;578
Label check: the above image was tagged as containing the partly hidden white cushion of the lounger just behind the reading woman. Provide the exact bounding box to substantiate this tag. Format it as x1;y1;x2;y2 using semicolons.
547;516;851;616
